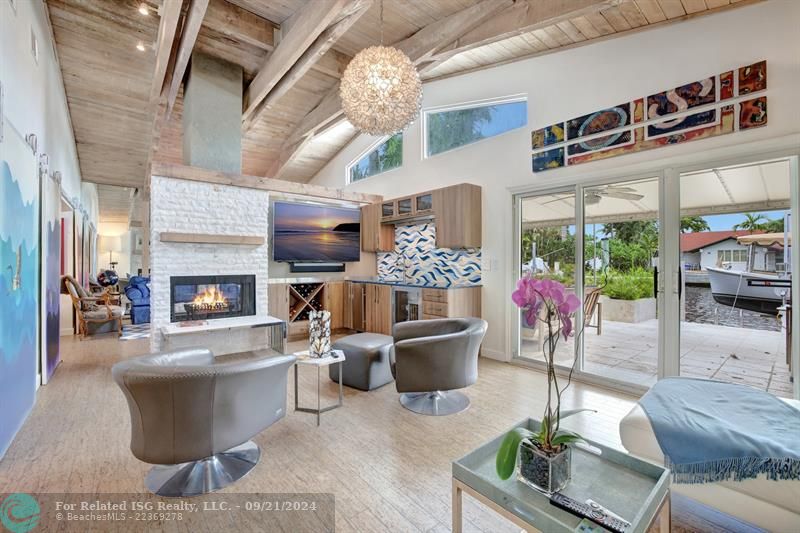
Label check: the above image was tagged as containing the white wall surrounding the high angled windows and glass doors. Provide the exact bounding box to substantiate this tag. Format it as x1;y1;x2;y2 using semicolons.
312;0;800;359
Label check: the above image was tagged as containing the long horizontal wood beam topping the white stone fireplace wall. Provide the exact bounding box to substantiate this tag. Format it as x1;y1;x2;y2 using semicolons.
153;163;383;204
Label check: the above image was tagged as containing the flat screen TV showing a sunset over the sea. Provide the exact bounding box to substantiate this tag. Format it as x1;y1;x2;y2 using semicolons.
272;202;361;263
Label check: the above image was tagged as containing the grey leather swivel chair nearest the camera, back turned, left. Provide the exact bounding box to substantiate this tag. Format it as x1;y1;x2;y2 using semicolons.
111;348;295;497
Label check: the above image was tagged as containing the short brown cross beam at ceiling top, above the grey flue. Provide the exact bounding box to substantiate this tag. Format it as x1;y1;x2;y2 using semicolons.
203;0;277;52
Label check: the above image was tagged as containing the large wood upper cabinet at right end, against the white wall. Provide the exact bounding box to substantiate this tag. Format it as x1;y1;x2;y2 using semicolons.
432;183;482;248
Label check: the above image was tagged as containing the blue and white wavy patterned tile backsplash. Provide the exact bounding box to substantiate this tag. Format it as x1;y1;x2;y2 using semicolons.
378;223;481;285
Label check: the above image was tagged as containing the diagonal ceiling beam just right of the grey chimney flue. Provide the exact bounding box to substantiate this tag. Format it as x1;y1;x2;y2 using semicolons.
242;0;372;130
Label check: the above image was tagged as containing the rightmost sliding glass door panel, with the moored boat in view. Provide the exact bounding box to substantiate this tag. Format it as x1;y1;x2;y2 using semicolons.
679;159;793;397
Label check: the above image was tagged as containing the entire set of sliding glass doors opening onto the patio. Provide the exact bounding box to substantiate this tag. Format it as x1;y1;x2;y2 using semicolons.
509;156;800;397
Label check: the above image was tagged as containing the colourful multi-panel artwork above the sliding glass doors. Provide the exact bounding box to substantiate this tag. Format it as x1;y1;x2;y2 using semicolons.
531;61;767;172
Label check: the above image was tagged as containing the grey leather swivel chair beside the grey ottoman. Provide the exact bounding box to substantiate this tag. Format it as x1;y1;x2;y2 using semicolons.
392;318;487;415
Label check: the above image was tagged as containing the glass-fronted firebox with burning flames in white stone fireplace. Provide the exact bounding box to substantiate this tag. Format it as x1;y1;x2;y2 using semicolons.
169;275;256;322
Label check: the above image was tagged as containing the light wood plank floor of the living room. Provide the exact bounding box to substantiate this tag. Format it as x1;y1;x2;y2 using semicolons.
0;337;635;532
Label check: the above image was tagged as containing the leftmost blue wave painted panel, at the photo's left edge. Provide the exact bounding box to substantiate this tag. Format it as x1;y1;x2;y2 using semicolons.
0;128;41;457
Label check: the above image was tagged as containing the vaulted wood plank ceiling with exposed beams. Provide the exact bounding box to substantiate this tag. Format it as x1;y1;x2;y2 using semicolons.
46;0;760;187
